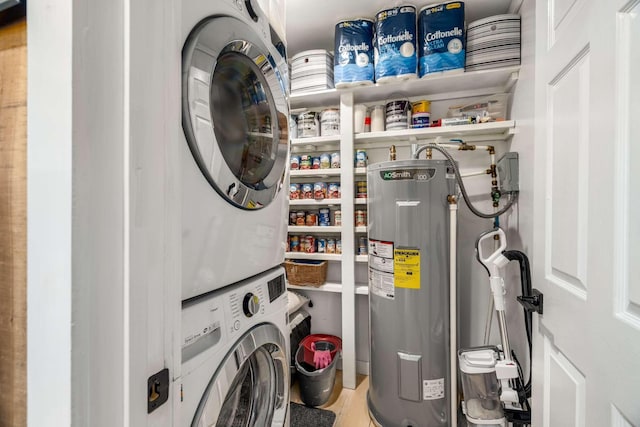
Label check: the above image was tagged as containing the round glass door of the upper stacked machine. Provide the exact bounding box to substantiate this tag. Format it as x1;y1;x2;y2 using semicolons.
182;16;289;209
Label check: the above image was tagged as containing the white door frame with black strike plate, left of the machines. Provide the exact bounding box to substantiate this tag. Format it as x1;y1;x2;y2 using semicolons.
27;0;181;427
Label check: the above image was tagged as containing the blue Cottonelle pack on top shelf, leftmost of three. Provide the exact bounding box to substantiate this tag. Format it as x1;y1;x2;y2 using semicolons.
333;18;374;89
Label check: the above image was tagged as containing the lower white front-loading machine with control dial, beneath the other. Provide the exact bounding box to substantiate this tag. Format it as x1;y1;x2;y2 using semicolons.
179;267;289;427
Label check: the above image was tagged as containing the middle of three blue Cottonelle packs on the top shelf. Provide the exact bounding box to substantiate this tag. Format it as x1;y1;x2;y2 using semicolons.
374;6;417;83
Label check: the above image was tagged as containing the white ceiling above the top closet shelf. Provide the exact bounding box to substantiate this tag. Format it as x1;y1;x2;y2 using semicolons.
285;0;518;57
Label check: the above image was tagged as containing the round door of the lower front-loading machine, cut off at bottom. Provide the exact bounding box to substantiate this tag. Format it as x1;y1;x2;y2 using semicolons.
191;324;289;427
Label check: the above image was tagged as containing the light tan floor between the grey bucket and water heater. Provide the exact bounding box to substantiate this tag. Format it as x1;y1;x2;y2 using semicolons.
291;371;375;427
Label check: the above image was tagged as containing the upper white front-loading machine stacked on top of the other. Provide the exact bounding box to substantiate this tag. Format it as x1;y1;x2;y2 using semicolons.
181;0;289;300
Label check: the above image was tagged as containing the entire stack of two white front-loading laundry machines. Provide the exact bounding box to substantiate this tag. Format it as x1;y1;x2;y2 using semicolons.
174;0;289;426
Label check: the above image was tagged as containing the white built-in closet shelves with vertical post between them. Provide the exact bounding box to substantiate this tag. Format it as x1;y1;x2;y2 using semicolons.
286;66;519;388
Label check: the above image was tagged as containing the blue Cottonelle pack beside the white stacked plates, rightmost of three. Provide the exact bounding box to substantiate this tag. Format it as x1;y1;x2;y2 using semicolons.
418;1;465;77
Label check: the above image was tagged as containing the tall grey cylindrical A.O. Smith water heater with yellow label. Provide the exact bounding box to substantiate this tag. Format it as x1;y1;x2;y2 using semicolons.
367;160;455;427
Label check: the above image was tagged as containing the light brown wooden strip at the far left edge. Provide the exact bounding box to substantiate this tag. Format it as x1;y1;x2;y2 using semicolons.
0;19;27;427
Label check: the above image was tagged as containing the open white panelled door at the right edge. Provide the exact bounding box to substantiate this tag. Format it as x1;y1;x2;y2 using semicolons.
533;0;640;427
